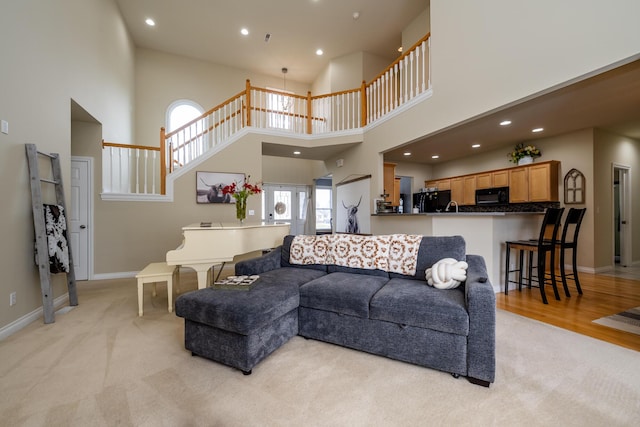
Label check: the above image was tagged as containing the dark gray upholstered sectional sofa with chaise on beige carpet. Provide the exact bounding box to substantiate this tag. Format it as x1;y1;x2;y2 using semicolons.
176;236;495;387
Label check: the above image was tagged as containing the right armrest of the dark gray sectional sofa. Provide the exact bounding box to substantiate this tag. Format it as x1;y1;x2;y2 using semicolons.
465;255;496;385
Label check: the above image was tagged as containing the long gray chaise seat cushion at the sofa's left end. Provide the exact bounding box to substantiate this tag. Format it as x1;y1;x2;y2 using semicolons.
176;268;325;335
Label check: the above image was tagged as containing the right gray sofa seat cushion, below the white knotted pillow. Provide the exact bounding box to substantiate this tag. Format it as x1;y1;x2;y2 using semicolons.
368;278;469;336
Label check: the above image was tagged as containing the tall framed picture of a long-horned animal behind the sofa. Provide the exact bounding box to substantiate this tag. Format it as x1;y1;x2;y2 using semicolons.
335;175;371;234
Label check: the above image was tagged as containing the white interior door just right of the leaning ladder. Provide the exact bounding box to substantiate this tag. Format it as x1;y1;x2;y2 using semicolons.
68;157;93;280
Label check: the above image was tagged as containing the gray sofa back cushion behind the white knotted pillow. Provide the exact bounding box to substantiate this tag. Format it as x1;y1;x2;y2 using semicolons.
389;236;467;281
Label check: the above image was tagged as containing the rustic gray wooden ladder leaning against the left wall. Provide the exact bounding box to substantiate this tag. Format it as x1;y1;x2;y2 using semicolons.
25;144;78;323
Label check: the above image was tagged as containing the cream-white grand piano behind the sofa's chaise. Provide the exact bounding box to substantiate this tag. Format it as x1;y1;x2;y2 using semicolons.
167;223;289;289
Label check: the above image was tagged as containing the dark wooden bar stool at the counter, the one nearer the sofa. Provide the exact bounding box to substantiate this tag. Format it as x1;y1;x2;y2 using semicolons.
504;208;564;304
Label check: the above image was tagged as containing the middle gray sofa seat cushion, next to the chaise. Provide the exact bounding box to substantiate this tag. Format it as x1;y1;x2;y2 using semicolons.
300;273;389;318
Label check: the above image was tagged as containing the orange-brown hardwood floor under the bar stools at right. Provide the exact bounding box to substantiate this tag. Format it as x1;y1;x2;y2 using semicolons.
496;273;640;351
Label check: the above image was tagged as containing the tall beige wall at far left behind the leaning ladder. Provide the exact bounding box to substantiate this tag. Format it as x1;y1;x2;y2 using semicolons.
0;0;134;326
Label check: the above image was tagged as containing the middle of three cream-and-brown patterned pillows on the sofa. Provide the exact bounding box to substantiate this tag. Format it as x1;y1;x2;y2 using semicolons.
327;234;391;271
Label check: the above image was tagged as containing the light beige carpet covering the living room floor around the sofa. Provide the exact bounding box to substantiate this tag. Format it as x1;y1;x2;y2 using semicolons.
0;279;640;426
